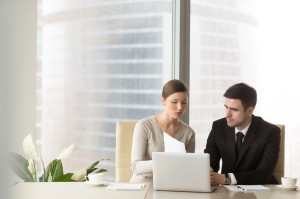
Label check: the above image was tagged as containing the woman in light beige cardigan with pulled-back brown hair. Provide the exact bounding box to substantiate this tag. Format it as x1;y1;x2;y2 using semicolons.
130;80;195;182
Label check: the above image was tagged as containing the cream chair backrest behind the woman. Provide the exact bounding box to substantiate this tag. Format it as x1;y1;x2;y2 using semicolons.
116;121;137;182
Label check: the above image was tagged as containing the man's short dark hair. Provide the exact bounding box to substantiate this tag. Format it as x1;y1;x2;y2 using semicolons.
223;83;257;110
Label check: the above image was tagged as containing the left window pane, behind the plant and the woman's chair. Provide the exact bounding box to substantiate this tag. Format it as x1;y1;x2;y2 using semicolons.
36;0;172;178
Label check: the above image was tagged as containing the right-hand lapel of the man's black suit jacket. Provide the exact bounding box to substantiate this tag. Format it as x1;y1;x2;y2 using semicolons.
236;115;257;169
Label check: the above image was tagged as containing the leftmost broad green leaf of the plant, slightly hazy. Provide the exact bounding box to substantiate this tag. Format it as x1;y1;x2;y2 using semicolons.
9;152;34;182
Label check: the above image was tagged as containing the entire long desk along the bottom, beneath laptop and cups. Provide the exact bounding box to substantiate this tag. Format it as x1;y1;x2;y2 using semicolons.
9;182;300;199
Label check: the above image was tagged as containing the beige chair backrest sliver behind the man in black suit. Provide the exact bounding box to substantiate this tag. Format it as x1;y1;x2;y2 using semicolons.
274;124;285;184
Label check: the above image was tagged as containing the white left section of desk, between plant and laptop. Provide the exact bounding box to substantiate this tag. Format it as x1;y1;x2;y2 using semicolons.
9;182;149;199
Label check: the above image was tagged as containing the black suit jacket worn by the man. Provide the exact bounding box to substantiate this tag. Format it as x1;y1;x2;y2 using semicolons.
204;115;280;184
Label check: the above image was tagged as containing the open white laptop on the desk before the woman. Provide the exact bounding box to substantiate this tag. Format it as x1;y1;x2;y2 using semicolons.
152;152;216;192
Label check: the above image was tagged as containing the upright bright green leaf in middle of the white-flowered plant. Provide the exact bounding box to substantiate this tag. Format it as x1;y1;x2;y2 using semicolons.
42;159;64;182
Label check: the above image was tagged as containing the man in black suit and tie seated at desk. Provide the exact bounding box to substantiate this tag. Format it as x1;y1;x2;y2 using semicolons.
204;83;280;185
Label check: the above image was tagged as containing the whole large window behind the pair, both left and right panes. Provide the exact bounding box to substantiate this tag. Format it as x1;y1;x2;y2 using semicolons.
36;0;300;182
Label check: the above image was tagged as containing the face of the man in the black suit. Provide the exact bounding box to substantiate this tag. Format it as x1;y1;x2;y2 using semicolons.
224;98;254;130
